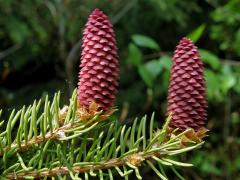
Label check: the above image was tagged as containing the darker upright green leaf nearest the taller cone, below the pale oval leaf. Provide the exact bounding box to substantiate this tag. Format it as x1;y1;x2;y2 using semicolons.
127;43;142;66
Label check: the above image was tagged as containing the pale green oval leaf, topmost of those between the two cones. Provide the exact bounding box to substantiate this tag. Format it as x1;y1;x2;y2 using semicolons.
132;34;160;50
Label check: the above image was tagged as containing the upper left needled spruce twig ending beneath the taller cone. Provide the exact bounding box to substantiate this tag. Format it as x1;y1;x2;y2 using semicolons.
0;90;108;157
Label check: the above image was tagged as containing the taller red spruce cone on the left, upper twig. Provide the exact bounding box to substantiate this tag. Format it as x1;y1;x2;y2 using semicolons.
78;9;119;111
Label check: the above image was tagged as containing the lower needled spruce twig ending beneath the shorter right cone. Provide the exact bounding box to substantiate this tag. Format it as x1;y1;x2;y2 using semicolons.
0;105;203;179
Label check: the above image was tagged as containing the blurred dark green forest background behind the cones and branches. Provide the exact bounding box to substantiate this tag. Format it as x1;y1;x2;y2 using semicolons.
0;0;240;180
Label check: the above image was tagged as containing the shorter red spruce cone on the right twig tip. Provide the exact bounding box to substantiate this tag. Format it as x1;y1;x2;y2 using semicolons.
168;38;207;131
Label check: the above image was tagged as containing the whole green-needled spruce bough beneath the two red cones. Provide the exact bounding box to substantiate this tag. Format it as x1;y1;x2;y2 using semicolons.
0;90;206;179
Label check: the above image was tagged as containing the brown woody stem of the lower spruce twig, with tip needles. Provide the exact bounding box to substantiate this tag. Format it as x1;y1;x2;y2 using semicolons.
5;142;203;179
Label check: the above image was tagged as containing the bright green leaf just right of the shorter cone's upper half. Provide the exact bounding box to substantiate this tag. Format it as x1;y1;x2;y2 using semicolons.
199;49;221;70
